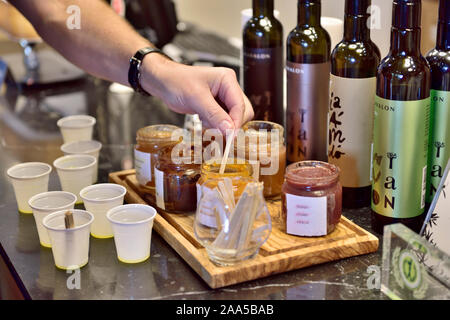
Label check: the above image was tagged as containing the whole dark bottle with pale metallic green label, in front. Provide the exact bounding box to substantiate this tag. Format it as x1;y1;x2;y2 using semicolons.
372;0;430;233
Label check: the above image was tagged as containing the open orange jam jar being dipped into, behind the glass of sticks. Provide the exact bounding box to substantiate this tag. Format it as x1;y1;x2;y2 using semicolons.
197;160;256;228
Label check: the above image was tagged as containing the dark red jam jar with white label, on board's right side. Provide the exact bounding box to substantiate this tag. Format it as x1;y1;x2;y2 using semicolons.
281;161;342;237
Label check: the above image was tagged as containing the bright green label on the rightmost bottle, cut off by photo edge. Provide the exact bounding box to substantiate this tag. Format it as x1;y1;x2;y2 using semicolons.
427;90;450;203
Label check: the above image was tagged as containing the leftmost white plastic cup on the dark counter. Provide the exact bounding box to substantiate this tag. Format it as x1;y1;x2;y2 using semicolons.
7;162;52;213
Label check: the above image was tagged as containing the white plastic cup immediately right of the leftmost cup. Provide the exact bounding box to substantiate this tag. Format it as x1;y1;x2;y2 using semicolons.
53;154;97;204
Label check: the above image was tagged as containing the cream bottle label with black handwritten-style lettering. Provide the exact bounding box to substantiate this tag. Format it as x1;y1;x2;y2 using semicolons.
328;75;377;188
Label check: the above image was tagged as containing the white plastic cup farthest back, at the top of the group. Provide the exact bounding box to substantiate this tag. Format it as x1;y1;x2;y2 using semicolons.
57;115;97;143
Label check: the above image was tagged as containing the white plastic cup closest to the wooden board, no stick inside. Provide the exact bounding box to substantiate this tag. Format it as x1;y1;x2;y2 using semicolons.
106;204;156;263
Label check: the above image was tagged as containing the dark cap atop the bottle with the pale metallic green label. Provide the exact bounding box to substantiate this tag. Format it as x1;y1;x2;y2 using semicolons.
392;0;422;29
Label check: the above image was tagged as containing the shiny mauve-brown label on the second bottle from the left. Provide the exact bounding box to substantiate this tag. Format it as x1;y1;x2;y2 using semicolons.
286;61;330;162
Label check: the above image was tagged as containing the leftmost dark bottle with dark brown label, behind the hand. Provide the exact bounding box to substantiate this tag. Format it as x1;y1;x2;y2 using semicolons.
243;0;284;126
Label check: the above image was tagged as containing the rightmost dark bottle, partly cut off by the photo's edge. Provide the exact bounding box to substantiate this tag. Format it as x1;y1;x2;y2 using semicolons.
426;0;450;204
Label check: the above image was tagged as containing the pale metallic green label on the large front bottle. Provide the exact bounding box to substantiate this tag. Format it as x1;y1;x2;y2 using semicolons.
372;96;430;218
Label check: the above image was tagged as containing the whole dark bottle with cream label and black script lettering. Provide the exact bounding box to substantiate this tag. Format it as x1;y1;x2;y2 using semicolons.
328;0;381;208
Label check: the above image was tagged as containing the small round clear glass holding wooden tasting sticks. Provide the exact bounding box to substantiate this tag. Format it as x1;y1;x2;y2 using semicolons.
194;181;272;266
